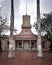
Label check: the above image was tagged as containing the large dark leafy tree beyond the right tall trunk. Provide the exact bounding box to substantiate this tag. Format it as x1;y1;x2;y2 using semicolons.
41;12;52;51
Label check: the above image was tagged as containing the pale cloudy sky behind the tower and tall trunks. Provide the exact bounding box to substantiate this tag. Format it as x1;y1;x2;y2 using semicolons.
0;0;52;33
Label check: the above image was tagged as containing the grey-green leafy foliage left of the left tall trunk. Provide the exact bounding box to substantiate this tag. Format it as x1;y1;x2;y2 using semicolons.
0;17;9;37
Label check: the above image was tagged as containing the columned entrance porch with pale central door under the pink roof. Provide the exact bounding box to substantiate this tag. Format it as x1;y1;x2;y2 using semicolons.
16;40;37;51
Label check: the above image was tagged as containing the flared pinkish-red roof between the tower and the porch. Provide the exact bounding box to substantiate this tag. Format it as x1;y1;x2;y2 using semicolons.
14;28;37;40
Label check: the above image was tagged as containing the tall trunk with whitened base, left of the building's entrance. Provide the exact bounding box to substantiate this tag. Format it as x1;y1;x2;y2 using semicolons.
8;0;15;58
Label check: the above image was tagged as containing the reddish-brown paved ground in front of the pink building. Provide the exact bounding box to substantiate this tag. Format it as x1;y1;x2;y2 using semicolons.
0;51;52;65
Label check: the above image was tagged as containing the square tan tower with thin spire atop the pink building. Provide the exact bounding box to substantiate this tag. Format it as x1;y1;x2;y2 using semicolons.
22;4;31;28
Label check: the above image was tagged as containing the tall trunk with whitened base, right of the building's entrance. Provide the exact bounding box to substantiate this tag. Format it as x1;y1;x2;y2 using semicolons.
37;0;43;57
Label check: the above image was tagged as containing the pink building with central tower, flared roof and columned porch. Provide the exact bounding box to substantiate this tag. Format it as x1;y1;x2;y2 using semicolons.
0;14;49;51
